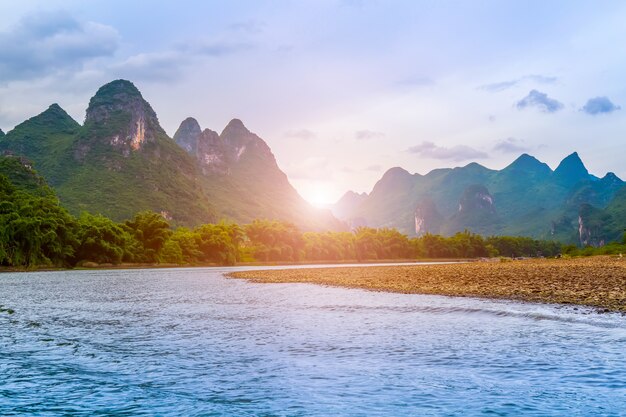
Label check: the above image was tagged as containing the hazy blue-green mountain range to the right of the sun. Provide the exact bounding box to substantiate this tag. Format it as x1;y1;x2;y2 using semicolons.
332;152;626;246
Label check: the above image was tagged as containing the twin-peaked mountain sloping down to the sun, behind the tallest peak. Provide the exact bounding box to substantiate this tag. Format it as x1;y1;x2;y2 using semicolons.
174;117;344;230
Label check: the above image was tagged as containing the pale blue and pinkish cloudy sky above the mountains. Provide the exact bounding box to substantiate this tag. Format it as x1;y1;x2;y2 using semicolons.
0;0;626;204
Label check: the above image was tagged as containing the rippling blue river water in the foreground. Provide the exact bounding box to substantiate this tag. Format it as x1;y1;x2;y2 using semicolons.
0;268;626;417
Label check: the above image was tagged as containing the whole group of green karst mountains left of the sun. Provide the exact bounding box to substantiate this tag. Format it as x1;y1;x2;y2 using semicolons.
0;80;345;230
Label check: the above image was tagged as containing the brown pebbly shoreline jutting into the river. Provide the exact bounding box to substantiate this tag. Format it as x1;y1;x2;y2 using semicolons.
227;256;626;314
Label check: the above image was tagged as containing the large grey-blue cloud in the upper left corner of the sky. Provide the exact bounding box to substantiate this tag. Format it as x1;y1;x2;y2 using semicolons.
0;12;120;82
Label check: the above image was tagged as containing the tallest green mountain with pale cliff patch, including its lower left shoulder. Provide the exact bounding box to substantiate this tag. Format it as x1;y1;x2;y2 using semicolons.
0;80;216;224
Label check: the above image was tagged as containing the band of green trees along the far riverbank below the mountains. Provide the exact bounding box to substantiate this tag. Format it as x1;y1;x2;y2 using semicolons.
0;171;561;267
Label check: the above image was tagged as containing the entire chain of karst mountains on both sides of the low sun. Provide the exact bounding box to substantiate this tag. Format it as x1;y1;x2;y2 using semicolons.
0;80;626;245
